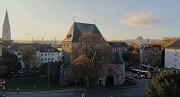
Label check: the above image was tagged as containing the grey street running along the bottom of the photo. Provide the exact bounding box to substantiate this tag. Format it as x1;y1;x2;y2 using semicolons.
1;79;147;97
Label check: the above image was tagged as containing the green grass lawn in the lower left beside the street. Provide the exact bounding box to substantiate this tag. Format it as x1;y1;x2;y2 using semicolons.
5;77;60;91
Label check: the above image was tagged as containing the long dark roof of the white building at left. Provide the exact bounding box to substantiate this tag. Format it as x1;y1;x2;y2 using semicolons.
12;43;59;52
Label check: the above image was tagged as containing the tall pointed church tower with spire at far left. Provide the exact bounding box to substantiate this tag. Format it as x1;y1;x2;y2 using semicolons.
2;9;11;41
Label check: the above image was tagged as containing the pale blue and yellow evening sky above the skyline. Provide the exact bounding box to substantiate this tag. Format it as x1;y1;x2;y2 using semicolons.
0;0;180;40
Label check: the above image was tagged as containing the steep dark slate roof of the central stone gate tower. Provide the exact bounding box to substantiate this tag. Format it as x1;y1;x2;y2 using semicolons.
64;22;102;42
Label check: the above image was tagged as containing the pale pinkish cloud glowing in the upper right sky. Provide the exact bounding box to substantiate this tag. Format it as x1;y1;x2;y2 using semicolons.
120;12;162;28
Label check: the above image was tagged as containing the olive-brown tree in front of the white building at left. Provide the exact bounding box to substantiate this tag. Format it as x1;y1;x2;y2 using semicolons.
19;46;36;68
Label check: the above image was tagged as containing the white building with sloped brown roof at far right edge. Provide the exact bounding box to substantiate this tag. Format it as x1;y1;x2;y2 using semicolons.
165;39;180;69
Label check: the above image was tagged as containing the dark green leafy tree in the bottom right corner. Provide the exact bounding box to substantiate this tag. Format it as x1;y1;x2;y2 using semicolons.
147;70;180;97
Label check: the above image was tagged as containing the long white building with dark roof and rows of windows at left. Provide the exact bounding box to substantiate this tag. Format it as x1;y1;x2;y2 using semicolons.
12;43;60;68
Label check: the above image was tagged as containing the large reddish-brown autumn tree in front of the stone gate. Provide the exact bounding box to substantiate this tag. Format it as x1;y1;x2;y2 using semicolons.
69;33;113;87
